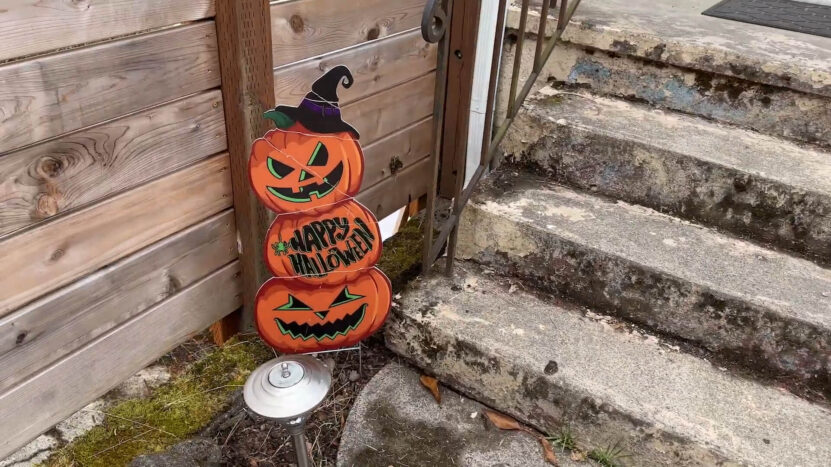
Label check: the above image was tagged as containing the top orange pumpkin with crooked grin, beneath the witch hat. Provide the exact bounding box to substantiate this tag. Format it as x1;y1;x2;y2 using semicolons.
248;122;364;213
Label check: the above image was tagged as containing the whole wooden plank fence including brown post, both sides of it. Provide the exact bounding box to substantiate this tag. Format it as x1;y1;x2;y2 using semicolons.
0;0;436;459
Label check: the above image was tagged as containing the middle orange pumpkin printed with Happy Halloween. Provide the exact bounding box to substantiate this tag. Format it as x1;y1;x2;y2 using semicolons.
264;199;383;284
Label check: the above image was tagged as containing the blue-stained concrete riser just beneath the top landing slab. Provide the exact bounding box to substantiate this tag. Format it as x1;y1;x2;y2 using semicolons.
540;45;831;147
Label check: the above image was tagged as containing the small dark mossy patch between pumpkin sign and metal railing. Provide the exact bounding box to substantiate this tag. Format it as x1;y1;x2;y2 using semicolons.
378;217;424;291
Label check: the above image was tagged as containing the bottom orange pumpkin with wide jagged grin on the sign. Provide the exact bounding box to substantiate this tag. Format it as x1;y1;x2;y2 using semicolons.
254;268;392;353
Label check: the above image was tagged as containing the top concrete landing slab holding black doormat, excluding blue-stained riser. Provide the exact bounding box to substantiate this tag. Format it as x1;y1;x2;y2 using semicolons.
508;0;831;96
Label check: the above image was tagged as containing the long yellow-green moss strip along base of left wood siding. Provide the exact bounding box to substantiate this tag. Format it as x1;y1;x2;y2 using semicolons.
46;337;273;467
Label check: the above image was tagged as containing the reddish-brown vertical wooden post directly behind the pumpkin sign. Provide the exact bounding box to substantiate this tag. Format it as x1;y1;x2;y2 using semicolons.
216;0;275;330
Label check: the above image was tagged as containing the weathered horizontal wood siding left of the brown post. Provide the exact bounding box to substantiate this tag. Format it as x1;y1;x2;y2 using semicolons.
0;0;240;459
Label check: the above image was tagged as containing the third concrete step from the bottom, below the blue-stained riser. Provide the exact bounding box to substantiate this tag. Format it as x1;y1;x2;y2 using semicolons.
503;87;831;265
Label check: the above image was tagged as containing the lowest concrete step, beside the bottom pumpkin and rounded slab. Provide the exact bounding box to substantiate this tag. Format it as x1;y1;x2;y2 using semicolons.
385;262;831;467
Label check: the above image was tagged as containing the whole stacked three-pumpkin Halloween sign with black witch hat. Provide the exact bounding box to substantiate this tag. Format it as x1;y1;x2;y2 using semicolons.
249;66;392;353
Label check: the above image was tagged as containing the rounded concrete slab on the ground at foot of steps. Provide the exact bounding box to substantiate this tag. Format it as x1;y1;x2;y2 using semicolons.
337;363;586;467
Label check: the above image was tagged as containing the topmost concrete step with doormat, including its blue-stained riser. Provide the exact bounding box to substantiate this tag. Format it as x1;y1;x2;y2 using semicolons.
503;0;831;146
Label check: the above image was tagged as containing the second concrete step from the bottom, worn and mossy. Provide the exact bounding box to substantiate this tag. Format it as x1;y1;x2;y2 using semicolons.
458;167;831;397
